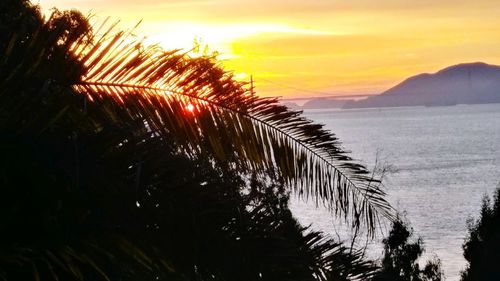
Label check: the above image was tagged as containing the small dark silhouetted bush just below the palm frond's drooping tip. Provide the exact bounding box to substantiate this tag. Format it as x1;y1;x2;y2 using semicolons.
373;219;443;281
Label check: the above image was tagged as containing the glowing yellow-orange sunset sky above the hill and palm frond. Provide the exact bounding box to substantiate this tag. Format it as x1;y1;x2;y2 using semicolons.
35;0;500;97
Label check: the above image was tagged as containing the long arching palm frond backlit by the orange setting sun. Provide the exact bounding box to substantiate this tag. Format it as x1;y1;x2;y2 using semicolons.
68;24;392;233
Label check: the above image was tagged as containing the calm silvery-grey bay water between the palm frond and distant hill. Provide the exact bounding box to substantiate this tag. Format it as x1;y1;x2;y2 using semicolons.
293;104;500;280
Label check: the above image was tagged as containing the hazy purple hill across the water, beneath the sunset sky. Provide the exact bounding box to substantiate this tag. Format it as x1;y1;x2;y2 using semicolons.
343;62;500;108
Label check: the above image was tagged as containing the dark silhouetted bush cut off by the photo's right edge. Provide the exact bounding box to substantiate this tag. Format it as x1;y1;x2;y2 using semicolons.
462;187;500;281
